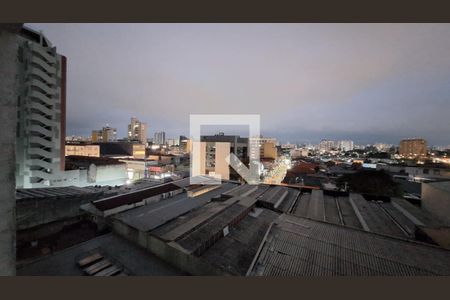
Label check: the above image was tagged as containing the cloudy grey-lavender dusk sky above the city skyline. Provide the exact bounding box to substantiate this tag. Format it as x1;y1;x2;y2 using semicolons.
27;24;450;146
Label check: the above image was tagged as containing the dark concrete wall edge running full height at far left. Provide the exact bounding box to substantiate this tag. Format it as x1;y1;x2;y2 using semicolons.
0;24;21;275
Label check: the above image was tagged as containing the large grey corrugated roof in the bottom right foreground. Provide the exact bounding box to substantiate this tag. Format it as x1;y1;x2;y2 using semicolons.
247;215;450;276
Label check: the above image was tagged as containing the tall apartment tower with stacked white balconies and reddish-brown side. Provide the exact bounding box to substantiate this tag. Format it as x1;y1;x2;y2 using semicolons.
16;27;67;188
